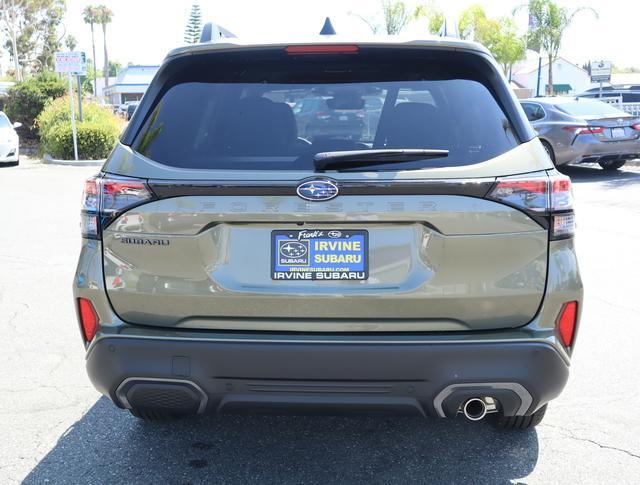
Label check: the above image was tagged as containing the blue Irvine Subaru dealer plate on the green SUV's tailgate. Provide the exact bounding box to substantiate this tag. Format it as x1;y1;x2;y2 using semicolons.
271;229;369;281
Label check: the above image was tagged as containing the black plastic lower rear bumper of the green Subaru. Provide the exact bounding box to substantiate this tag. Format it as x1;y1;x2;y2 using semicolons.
87;334;568;417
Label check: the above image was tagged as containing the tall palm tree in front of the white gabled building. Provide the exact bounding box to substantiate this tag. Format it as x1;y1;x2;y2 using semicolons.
527;0;598;94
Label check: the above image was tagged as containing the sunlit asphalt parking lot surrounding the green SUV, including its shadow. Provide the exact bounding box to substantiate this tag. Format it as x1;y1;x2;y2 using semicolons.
0;162;640;484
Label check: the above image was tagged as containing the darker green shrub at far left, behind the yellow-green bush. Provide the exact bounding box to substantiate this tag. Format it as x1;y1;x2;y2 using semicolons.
4;72;67;138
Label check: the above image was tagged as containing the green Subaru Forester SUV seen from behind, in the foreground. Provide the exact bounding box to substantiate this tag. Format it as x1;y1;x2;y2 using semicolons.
74;25;582;428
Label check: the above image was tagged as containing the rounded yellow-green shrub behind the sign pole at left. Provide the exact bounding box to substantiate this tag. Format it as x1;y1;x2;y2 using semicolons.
36;97;122;160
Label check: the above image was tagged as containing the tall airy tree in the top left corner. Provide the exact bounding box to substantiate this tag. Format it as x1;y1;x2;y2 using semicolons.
0;0;66;80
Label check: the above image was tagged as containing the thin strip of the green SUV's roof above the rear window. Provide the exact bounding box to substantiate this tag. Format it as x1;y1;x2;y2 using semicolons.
167;34;489;58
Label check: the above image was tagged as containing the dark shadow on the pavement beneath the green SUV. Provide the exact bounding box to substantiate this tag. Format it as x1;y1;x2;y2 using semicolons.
24;398;538;484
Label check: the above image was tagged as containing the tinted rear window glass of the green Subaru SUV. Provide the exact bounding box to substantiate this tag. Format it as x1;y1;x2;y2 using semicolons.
132;47;518;170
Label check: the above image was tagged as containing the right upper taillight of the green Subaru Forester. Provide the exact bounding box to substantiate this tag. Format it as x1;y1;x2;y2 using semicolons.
488;174;575;239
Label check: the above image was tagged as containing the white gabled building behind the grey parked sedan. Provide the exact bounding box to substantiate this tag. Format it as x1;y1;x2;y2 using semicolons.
511;52;591;96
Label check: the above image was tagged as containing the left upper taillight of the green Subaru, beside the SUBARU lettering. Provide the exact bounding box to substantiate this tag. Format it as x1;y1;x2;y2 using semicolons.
80;175;154;239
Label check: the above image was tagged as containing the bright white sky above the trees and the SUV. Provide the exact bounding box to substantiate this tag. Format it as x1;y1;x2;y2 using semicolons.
64;0;640;67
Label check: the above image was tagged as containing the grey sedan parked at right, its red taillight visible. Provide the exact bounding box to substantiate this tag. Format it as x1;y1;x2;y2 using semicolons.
520;97;640;170
